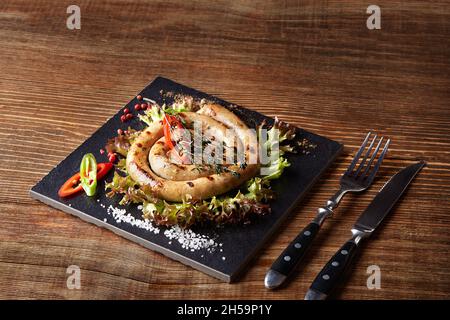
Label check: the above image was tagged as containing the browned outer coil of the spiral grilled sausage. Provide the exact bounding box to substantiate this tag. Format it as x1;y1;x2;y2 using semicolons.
127;105;259;202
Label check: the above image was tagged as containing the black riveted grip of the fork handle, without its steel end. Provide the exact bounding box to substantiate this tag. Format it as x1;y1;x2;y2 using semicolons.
269;222;320;288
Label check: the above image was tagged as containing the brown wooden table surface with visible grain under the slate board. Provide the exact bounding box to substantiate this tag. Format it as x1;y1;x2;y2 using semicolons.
0;0;450;299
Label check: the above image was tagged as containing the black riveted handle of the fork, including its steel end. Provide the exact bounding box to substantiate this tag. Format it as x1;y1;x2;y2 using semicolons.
265;222;320;289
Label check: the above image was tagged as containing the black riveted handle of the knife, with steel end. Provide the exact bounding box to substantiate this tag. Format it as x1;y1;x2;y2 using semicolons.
305;238;359;300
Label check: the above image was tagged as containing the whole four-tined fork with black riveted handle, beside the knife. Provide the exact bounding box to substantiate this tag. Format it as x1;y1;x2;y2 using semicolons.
264;132;390;289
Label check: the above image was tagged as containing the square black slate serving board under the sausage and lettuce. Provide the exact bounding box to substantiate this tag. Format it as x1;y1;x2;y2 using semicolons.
30;77;342;282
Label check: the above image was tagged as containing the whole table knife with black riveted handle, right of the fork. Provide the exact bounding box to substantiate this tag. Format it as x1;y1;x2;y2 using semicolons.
305;161;425;300
